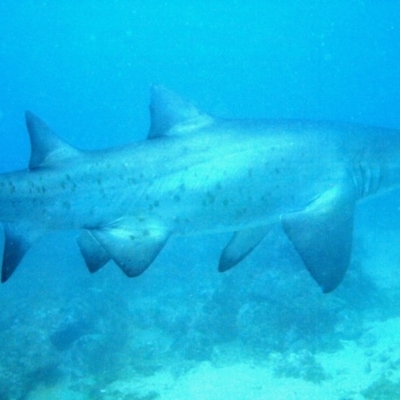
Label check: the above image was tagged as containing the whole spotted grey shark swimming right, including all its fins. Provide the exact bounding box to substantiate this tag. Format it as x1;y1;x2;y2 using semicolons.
0;86;400;292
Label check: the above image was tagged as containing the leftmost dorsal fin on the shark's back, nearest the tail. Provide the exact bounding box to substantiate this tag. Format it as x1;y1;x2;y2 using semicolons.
25;111;80;170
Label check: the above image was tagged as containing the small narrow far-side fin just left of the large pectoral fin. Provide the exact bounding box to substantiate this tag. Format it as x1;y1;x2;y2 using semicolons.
218;225;271;272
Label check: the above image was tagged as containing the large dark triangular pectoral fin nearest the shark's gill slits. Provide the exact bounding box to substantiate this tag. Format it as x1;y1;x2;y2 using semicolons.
282;184;356;293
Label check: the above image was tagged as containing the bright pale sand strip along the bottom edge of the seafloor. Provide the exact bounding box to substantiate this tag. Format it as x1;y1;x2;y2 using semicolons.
28;318;400;400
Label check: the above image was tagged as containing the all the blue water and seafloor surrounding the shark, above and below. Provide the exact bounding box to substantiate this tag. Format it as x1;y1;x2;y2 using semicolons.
0;0;400;400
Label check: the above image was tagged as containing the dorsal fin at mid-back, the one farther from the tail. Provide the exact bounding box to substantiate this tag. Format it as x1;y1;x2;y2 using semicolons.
147;86;213;139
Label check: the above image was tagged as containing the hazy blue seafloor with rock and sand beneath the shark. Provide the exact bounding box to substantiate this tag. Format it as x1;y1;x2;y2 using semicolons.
0;214;400;400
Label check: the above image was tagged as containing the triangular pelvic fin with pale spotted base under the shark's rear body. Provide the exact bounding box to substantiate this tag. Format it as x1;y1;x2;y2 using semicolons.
91;224;168;277
